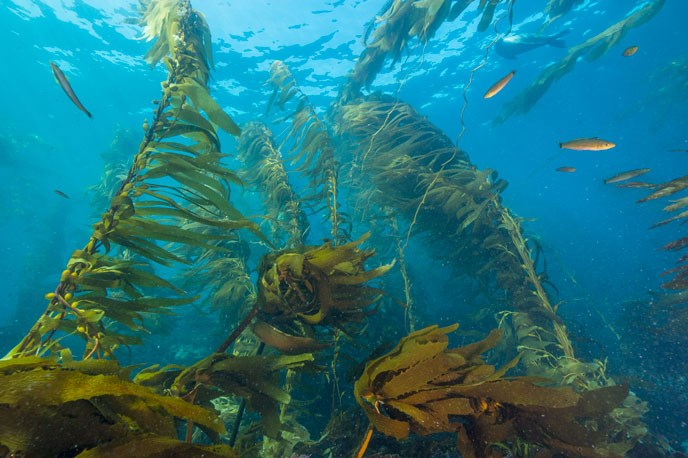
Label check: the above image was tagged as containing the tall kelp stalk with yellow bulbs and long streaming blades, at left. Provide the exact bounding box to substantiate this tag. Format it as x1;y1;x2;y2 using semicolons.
7;1;254;358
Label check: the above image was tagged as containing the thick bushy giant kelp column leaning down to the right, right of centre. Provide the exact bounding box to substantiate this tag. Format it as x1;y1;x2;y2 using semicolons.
330;97;640;450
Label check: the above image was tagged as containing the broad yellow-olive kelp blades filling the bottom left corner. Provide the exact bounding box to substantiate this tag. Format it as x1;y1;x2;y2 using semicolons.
0;357;237;457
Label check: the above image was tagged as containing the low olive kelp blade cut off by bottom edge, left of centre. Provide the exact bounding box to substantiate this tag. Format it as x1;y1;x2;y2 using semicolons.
77;435;239;458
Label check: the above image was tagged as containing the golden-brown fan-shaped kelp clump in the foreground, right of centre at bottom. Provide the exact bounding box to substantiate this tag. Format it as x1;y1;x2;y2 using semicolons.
354;325;630;457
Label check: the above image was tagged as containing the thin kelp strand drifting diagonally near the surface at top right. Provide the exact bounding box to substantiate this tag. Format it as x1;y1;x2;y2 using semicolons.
495;0;664;122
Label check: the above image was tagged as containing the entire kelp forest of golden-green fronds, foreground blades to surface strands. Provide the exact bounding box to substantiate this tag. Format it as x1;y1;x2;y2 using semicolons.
0;0;688;458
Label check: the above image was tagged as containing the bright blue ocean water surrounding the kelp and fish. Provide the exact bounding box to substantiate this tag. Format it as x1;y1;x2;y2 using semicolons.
0;0;688;456
